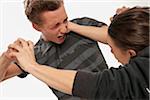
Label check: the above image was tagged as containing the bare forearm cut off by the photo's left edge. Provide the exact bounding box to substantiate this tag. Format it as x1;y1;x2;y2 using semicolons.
0;54;11;81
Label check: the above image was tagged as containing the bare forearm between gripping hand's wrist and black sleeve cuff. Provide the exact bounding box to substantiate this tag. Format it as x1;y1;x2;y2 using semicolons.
27;64;76;94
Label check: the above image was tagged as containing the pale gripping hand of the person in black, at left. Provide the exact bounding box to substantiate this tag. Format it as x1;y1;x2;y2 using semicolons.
9;39;36;72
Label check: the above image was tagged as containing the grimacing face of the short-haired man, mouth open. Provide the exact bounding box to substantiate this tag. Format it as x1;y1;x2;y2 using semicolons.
34;5;68;44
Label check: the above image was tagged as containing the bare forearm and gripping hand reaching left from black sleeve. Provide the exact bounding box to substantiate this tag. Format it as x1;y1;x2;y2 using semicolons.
9;40;76;94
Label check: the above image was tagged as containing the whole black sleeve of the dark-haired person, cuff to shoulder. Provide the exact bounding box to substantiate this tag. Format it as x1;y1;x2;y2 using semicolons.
72;62;149;100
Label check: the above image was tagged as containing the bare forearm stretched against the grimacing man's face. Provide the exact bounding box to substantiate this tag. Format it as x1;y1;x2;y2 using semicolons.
68;22;108;44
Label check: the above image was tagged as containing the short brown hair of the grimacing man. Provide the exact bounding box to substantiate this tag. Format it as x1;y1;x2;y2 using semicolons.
24;0;63;25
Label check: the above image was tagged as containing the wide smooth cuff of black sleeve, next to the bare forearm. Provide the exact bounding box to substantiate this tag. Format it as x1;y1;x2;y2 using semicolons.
72;70;101;98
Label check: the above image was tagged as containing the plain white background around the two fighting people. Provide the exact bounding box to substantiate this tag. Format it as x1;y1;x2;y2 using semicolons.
0;0;149;100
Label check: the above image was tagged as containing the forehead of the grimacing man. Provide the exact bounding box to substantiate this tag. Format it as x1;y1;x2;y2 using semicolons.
41;5;67;24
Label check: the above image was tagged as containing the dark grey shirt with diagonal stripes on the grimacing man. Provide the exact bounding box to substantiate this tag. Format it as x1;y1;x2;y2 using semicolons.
19;17;107;100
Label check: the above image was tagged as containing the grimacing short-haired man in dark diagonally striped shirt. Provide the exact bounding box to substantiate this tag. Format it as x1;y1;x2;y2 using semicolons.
0;0;107;100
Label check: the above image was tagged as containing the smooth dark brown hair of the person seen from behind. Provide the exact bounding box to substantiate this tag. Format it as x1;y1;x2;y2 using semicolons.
108;7;150;52
